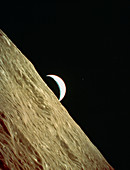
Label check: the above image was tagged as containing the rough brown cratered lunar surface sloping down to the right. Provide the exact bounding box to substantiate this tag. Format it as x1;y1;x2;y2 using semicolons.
0;30;113;170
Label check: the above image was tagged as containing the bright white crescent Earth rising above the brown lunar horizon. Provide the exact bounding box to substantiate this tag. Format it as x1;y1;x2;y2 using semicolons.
47;74;66;101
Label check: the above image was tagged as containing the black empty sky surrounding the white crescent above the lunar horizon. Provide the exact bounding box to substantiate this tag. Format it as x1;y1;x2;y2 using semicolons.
0;1;130;170
